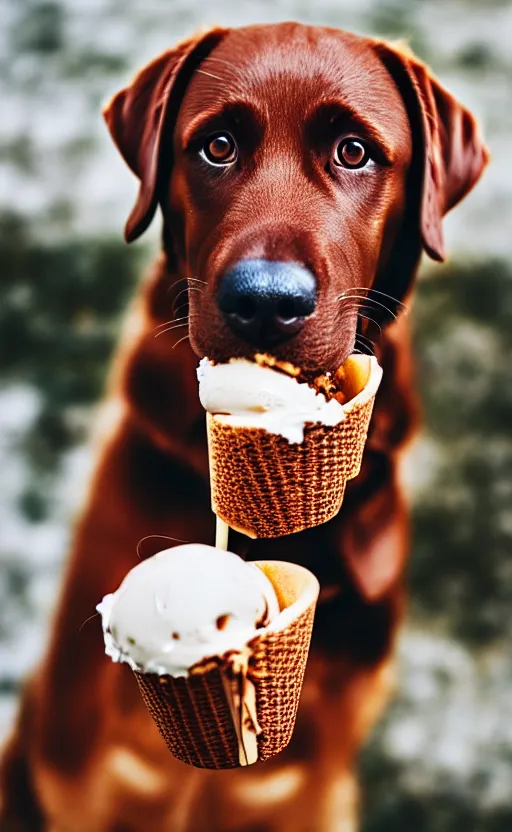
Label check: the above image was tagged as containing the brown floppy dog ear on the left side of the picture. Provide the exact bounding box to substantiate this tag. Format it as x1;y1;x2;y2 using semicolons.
103;28;227;242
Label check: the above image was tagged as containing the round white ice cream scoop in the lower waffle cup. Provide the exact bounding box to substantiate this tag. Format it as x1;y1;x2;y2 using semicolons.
97;543;279;676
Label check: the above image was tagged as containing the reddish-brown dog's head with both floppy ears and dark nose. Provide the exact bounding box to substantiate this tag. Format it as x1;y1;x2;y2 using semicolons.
105;23;487;370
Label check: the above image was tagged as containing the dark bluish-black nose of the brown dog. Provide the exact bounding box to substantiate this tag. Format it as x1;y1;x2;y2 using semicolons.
217;260;316;347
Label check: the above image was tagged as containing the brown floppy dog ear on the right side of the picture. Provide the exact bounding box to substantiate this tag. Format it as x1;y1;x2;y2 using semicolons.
374;41;489;261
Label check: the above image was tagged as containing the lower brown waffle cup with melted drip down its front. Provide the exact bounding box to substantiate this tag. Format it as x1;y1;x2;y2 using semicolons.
135;561;318;769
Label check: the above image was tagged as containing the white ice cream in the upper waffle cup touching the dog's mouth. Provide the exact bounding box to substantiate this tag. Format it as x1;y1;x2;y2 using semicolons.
197;358;345;443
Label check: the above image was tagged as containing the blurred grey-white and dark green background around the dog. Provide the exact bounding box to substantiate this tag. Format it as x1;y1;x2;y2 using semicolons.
0;0;512;832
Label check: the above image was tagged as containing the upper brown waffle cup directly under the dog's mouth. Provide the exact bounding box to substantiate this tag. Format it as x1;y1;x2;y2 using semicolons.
207;356;381;537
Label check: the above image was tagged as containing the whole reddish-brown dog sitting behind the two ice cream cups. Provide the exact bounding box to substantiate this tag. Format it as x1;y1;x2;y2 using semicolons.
2;23;487;832
